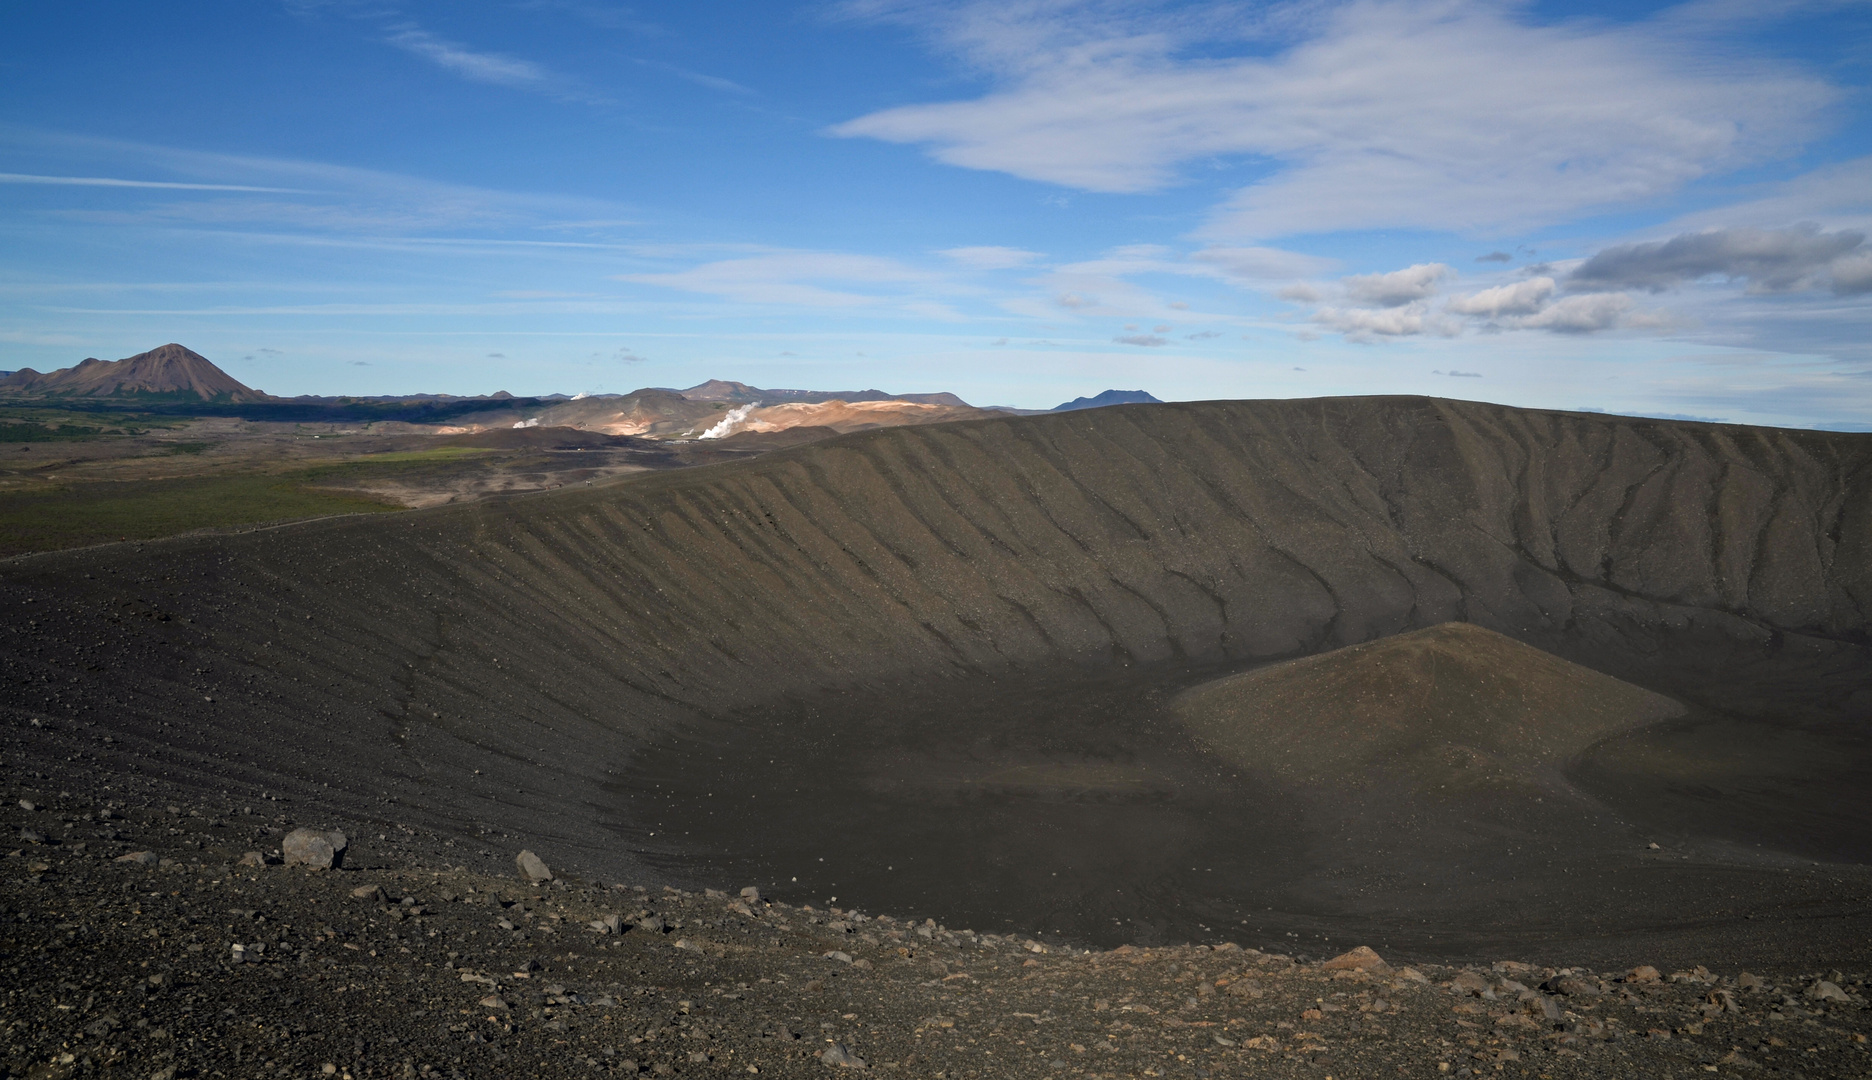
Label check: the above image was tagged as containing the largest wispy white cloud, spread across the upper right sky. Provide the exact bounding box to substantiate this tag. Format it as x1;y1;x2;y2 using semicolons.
833;0;1836;238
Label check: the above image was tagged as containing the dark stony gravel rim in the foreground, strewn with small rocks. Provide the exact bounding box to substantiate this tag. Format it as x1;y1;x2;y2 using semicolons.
0;777;1872;1080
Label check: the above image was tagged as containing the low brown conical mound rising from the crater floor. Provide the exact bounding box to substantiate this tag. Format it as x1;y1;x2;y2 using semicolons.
1172;623;1685;788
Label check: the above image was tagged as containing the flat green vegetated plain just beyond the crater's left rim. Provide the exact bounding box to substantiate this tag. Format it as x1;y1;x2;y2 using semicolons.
0;474;401;558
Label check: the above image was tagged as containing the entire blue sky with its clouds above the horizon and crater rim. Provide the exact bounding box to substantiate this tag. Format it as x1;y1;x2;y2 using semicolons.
0;0;1872;429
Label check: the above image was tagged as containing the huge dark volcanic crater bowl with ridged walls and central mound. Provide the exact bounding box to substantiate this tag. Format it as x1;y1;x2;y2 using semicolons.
0;399;1872;964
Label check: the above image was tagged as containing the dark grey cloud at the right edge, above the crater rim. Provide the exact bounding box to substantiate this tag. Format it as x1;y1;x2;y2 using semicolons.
1567;225;1866;294
